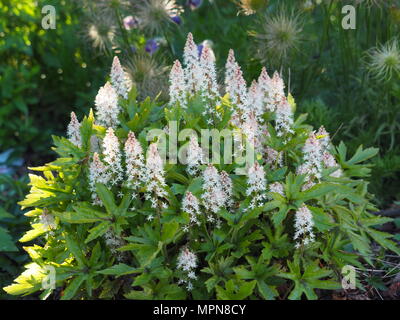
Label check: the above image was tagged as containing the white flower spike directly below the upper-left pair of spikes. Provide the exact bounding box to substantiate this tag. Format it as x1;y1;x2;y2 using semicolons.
103;128;123;185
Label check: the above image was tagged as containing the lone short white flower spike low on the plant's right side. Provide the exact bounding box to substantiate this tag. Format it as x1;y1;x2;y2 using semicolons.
294;205;315;248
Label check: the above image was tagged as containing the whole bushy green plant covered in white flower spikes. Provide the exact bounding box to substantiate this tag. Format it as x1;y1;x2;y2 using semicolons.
4;34;400;299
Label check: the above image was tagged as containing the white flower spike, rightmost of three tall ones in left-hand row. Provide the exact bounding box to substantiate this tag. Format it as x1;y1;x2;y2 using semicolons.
144;143;167;209
